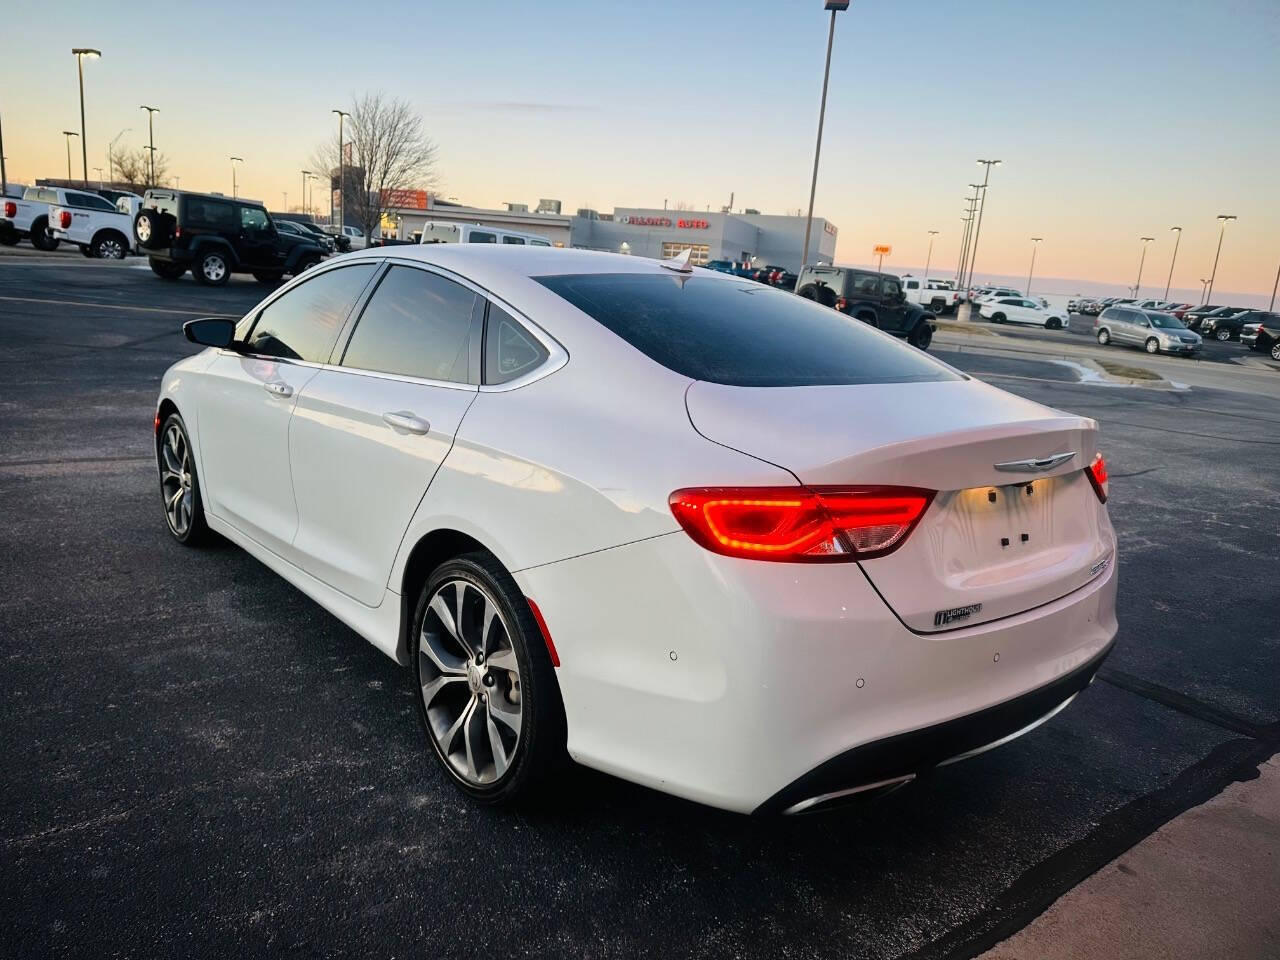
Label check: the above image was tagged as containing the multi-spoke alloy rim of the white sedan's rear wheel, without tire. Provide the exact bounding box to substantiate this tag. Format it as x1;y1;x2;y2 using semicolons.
419;579;524;786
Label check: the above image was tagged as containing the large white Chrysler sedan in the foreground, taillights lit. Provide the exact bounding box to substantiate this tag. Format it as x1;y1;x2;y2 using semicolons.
155;244;1116;813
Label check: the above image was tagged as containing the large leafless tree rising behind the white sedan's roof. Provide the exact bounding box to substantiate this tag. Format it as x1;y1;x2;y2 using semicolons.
311;92;438;241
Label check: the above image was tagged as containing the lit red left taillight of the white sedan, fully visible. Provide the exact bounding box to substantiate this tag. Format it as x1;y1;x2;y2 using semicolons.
669;486;933;563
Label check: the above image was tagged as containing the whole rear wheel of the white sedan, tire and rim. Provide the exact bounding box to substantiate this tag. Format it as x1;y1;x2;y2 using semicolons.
410;553;564;803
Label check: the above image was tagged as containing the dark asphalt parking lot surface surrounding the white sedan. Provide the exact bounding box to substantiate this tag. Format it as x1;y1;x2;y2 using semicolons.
0;259;1280;957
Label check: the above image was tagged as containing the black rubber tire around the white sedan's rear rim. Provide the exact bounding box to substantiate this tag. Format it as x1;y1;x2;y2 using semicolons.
410;552;567;804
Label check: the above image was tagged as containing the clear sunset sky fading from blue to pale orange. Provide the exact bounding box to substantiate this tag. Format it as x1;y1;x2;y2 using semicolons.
0;0;1280;296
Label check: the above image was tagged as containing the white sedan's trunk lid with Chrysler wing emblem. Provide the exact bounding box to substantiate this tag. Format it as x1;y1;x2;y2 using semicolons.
686;380;1114;632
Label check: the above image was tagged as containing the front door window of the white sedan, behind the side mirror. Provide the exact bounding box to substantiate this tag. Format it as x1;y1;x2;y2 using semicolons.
247;264;375;364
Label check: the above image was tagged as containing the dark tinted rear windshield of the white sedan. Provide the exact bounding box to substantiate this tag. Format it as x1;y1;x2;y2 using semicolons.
535;274;959;387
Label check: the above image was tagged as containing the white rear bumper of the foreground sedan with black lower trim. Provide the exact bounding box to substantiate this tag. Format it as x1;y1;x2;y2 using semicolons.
515;532;1117;813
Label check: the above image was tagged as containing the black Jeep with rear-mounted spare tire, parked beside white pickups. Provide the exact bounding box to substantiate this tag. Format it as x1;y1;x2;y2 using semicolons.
133;189;325;287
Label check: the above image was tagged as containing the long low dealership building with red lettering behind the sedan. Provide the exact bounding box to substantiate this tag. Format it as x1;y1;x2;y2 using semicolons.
383;195;837;270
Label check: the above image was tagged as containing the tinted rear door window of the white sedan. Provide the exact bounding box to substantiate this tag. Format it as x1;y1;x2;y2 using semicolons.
342;266;476;383
